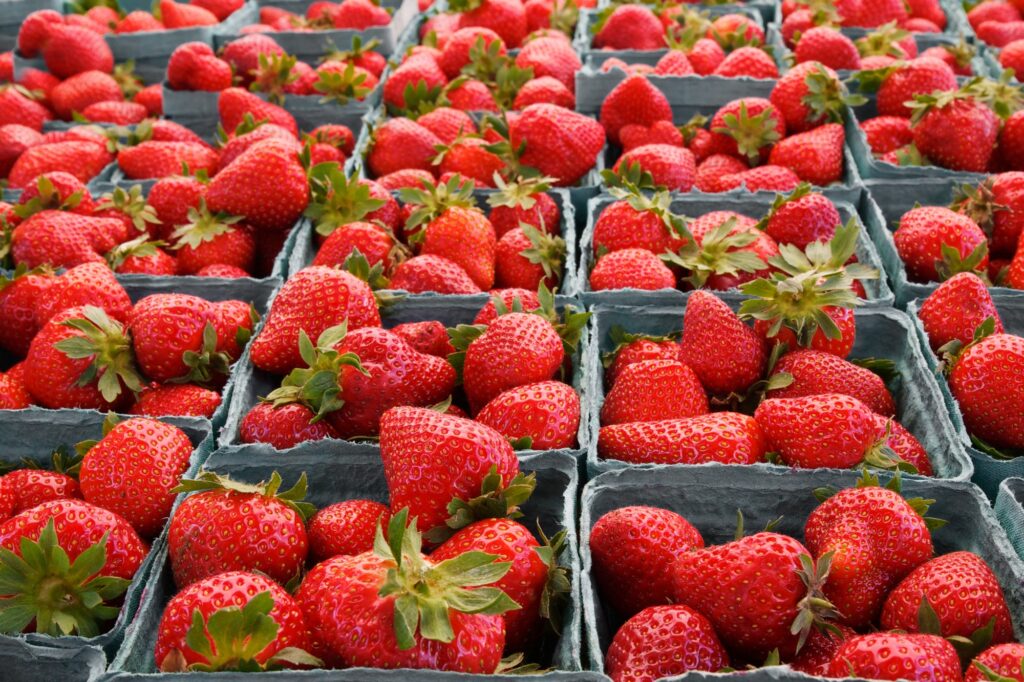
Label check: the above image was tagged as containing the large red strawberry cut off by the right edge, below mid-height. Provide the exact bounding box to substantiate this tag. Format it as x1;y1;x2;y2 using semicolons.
949;334;1024;449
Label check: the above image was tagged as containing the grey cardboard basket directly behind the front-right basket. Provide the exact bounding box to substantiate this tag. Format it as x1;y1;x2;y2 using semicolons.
584;301;974;481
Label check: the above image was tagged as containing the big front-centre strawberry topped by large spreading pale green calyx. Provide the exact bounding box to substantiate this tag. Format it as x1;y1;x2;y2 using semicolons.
296;509;516;674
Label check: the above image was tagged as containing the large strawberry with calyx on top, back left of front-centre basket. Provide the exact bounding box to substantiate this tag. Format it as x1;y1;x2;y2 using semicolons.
167;472;313;588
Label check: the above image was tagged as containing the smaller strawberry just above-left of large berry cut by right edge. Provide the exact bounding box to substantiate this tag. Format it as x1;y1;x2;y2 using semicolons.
918;272;1004;352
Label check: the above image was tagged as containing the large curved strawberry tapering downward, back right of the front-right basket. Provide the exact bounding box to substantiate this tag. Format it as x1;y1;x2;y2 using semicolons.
804;487;933;628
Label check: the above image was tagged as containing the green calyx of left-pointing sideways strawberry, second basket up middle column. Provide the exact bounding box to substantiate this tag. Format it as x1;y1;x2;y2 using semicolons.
263;321;370;423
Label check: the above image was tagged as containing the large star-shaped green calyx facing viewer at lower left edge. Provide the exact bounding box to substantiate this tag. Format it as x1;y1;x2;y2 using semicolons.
0;519;129;637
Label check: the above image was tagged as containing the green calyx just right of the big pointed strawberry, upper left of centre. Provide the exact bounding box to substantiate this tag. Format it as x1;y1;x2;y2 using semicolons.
305;163;387;237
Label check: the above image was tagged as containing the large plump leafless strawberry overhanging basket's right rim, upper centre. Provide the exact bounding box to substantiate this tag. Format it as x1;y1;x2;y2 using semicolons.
509;104;604;186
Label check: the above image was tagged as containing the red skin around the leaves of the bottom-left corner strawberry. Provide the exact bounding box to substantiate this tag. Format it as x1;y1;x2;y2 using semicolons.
0;493;150;580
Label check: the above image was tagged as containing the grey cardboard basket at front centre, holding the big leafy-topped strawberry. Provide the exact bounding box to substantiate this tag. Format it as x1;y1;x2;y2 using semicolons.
108;441;585;682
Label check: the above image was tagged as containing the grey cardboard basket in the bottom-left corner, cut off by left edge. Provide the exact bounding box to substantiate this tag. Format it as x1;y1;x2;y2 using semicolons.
0;410;213;682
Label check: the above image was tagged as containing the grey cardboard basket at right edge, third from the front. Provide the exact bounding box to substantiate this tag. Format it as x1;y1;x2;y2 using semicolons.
860;173;1024;307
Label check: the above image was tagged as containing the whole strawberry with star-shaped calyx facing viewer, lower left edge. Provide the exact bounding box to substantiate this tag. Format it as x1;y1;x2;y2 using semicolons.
0;500;148;637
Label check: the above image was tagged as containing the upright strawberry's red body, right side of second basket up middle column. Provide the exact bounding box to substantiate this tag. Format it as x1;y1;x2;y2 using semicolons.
463;312;565;413
